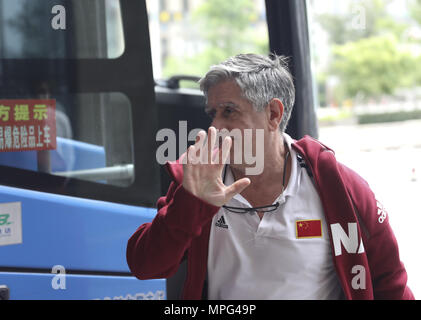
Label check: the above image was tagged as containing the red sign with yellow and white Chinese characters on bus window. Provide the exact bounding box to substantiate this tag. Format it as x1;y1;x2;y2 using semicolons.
0;100;56;152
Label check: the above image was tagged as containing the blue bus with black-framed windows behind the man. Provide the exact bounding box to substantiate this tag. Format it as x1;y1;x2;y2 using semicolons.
0;0;317;300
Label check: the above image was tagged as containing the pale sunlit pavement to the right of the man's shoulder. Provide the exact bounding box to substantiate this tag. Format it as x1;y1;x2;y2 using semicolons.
319;120;421;299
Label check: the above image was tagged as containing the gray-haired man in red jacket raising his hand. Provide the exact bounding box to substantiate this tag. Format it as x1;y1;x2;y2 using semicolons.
127;54;413;299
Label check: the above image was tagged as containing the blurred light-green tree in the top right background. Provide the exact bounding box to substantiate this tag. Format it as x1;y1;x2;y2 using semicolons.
316;0;421;104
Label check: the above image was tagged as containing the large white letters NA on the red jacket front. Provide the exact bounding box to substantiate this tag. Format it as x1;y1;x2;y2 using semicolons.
330;222;364;256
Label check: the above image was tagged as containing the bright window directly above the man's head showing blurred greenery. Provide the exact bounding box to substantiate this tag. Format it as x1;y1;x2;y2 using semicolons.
146;0;269;87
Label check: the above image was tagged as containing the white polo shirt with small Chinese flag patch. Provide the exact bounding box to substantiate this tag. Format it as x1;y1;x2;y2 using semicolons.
208;134;342;300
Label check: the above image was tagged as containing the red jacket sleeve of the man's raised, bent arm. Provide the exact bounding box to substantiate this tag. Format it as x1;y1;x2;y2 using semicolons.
126;182;219;280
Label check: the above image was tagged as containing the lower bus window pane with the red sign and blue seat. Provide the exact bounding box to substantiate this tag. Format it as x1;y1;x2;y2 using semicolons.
0;92;134;186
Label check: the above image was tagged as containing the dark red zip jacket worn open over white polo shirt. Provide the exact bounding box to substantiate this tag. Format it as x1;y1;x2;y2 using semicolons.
127;136;414;299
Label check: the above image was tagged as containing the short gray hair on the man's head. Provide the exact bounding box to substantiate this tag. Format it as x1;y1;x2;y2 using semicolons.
199;54;295;132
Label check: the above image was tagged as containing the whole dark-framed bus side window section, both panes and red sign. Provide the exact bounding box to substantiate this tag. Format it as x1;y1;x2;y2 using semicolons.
0;0;159;206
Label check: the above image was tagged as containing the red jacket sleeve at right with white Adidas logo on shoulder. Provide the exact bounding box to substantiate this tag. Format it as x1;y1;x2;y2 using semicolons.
346;165;414;300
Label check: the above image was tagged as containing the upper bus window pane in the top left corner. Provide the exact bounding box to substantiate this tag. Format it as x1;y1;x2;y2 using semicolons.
0;0;124;59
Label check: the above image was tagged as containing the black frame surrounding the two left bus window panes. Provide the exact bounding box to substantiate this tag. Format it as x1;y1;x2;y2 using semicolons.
0;0;160;207
